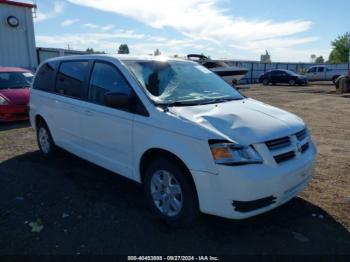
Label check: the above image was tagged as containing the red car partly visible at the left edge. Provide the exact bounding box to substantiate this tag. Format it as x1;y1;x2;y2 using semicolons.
0;67;33;122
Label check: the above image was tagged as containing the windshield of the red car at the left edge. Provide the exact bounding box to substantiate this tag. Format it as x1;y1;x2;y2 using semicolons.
0;72;33;89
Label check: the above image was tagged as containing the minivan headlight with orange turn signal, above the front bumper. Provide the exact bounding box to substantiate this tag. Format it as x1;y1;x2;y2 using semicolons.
210;143;263;165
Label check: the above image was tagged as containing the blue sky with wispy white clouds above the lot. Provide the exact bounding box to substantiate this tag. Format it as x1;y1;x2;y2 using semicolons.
28;0;350;62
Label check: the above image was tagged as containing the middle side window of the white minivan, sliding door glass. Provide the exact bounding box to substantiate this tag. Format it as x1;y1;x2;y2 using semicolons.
55;61;88;99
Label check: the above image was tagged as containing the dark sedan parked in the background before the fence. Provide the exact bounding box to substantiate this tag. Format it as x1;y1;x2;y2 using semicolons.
259;69;308;86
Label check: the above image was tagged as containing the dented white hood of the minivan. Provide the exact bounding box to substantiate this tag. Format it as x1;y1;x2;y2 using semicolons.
170;99;305;145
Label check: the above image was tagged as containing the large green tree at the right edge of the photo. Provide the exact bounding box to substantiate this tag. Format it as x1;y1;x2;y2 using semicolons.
329;32;350;64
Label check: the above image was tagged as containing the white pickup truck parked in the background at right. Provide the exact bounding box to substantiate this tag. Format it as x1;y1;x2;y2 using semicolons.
305;65;347;82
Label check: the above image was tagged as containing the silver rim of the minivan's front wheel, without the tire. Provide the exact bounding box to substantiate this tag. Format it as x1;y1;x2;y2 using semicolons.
151;170;183;217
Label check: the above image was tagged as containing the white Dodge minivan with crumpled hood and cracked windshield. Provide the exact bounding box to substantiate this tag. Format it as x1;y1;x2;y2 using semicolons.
30;55;316;225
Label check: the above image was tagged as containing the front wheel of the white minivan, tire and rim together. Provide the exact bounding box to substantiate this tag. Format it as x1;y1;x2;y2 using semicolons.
144;158;199;227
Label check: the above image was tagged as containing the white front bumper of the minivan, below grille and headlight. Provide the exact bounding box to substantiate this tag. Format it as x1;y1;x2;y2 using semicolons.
192;143;316;219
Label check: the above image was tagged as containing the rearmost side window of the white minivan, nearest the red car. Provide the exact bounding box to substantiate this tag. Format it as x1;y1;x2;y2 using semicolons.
33;61;58;92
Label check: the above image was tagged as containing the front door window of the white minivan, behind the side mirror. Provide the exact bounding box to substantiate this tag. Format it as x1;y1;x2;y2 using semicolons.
89;62;131;105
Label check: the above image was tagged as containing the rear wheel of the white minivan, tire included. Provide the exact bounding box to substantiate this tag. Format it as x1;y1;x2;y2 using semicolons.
36;121;57;158
